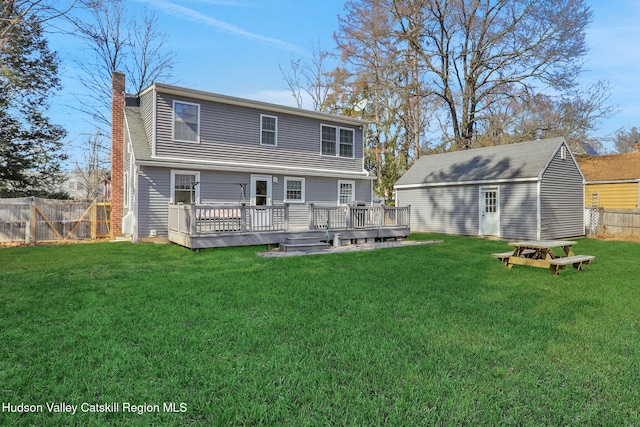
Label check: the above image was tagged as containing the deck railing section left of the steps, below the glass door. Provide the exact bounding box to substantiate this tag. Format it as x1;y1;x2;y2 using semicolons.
169;204;289;236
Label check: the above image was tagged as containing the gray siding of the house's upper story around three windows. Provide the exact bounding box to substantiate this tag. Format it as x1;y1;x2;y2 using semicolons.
154;93;364;173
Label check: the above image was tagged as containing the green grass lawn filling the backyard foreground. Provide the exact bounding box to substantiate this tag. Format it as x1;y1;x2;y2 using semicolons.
0;235;640;426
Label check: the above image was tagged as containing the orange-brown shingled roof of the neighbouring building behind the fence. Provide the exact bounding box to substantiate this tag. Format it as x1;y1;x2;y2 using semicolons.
576;152;640;182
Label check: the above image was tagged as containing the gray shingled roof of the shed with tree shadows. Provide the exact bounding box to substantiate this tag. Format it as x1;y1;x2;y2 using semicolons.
396;138;564;187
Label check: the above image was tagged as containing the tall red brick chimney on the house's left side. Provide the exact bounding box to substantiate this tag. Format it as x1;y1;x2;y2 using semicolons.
111;71;125;239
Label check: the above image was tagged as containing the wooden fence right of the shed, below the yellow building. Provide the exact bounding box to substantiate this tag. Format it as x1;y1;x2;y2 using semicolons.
585;207;640;237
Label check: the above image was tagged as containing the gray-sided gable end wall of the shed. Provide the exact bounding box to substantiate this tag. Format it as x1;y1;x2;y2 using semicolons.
540;149;584;239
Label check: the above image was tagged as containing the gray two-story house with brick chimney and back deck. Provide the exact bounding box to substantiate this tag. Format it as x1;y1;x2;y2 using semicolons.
112;73;408;248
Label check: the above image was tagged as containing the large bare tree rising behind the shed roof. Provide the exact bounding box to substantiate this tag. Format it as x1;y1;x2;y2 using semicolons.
391;0;591;149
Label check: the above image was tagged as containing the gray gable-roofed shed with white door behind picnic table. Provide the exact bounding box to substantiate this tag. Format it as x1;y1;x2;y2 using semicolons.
395;138;584;240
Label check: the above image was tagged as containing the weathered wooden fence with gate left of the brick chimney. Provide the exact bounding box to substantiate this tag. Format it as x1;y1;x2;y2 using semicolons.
0;198;111;244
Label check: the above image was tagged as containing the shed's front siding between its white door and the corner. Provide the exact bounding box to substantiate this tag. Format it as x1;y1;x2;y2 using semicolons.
498;182;538;240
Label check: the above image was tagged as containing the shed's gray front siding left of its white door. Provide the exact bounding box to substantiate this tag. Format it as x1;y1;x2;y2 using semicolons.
397;185;479;235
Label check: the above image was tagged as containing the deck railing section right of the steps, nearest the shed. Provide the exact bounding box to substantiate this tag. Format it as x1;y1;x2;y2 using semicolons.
309;204;411;230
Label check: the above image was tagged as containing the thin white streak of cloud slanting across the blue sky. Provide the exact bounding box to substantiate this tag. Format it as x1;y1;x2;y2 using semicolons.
138;0;304;53
